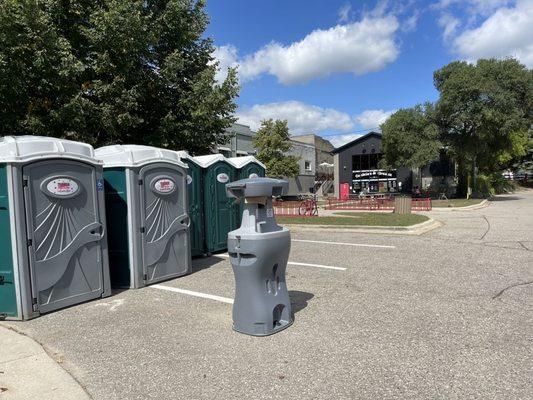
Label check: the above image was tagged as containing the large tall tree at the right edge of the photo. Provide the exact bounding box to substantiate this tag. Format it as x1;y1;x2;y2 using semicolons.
434;59;533;194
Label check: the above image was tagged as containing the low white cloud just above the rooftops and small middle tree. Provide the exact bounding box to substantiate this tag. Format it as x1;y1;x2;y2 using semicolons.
237;101;354;135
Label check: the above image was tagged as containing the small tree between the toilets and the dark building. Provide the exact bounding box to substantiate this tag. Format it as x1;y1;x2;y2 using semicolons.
254;119;300;178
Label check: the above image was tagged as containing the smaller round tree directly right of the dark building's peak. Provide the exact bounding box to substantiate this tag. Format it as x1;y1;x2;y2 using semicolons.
381;103;442;169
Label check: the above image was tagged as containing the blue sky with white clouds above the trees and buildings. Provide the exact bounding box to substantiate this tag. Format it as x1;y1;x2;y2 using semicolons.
206;0;533;146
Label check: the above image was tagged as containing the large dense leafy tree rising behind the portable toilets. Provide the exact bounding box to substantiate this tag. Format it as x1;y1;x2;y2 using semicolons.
0;0;238;154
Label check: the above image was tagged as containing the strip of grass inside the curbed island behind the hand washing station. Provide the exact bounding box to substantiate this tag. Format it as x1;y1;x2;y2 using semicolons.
276;211;428;226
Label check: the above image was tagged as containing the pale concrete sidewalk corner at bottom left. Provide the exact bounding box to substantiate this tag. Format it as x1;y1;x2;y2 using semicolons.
0;326;90;400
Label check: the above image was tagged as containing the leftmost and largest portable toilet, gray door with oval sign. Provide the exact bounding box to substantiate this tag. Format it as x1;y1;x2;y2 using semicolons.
0;136;111;320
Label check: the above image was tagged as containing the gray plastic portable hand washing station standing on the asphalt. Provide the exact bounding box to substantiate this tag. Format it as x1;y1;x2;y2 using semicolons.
226;178;293;336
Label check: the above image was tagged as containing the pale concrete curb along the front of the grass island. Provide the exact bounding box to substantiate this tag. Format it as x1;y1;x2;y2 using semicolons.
283;218;443;236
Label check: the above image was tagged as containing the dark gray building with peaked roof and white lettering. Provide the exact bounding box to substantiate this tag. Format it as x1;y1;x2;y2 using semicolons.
332;132;412;198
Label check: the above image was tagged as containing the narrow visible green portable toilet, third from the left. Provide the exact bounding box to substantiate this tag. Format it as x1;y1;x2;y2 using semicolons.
178;151;206;257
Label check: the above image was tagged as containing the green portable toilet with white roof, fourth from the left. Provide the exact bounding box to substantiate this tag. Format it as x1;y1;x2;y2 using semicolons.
193;154;238;253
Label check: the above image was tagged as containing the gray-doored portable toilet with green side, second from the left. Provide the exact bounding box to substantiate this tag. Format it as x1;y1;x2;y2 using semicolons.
96;145;191;288
